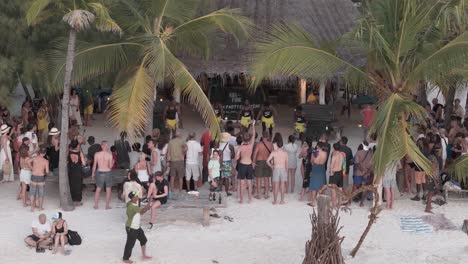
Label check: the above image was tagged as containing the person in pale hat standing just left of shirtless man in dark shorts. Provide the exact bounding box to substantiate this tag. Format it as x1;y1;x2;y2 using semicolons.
218;132;236;196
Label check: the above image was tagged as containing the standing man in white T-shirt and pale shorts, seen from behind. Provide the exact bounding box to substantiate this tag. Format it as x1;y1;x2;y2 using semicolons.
185;132;203;191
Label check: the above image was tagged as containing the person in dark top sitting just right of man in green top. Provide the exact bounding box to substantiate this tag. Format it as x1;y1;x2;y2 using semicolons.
147;171;169;229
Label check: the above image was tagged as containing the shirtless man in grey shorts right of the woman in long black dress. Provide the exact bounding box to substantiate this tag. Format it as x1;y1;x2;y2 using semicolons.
91;141;114;209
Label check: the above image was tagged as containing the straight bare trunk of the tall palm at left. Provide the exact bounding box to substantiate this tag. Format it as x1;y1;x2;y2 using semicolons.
59;28;76;211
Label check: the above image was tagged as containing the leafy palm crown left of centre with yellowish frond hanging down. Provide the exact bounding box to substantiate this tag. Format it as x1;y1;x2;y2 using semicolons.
47;0;251;136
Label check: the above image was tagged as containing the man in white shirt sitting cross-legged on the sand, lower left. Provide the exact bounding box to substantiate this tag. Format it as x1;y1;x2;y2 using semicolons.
24;214;52;252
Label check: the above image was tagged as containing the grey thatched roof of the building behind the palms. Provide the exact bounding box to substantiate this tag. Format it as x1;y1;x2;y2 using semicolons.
183;0;359;74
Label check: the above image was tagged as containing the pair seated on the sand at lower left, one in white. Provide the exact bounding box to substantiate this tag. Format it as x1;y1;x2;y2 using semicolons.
24;212;68;255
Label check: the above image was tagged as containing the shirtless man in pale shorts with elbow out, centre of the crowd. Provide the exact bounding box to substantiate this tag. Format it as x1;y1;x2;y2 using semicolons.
267;134;288;204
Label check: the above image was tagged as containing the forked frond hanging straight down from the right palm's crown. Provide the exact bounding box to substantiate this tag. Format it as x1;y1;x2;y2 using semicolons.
370;93;432;181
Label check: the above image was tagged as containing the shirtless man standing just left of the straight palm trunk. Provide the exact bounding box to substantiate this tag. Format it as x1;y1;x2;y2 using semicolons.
29;148;49;212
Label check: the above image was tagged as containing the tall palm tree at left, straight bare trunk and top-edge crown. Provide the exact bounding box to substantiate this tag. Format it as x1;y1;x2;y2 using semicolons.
26;0;121;211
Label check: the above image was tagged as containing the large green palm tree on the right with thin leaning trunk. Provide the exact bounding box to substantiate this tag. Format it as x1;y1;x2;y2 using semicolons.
251;0;468;256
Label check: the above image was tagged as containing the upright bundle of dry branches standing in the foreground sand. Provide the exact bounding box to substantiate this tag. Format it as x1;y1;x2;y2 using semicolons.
302;195;344;264
